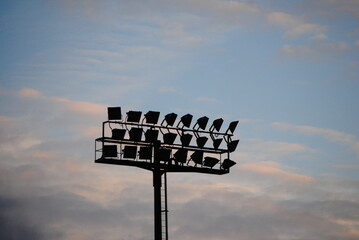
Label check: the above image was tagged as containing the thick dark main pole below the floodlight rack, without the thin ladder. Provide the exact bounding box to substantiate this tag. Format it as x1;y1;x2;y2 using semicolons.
153;167;162;240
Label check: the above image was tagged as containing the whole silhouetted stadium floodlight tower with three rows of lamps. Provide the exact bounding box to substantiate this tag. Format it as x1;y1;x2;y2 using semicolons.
95;107;239;240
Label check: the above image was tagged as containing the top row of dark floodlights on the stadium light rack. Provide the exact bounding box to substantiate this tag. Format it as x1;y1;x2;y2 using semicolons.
108;107;238;134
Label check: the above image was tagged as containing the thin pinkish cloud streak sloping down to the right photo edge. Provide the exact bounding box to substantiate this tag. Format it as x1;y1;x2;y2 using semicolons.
272;122;359;153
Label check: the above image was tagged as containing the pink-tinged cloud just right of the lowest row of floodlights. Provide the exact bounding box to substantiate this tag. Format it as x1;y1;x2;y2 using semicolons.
238;161;314;183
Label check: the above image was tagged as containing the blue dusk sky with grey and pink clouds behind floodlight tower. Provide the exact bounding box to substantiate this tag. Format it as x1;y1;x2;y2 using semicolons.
0;0;359;240
